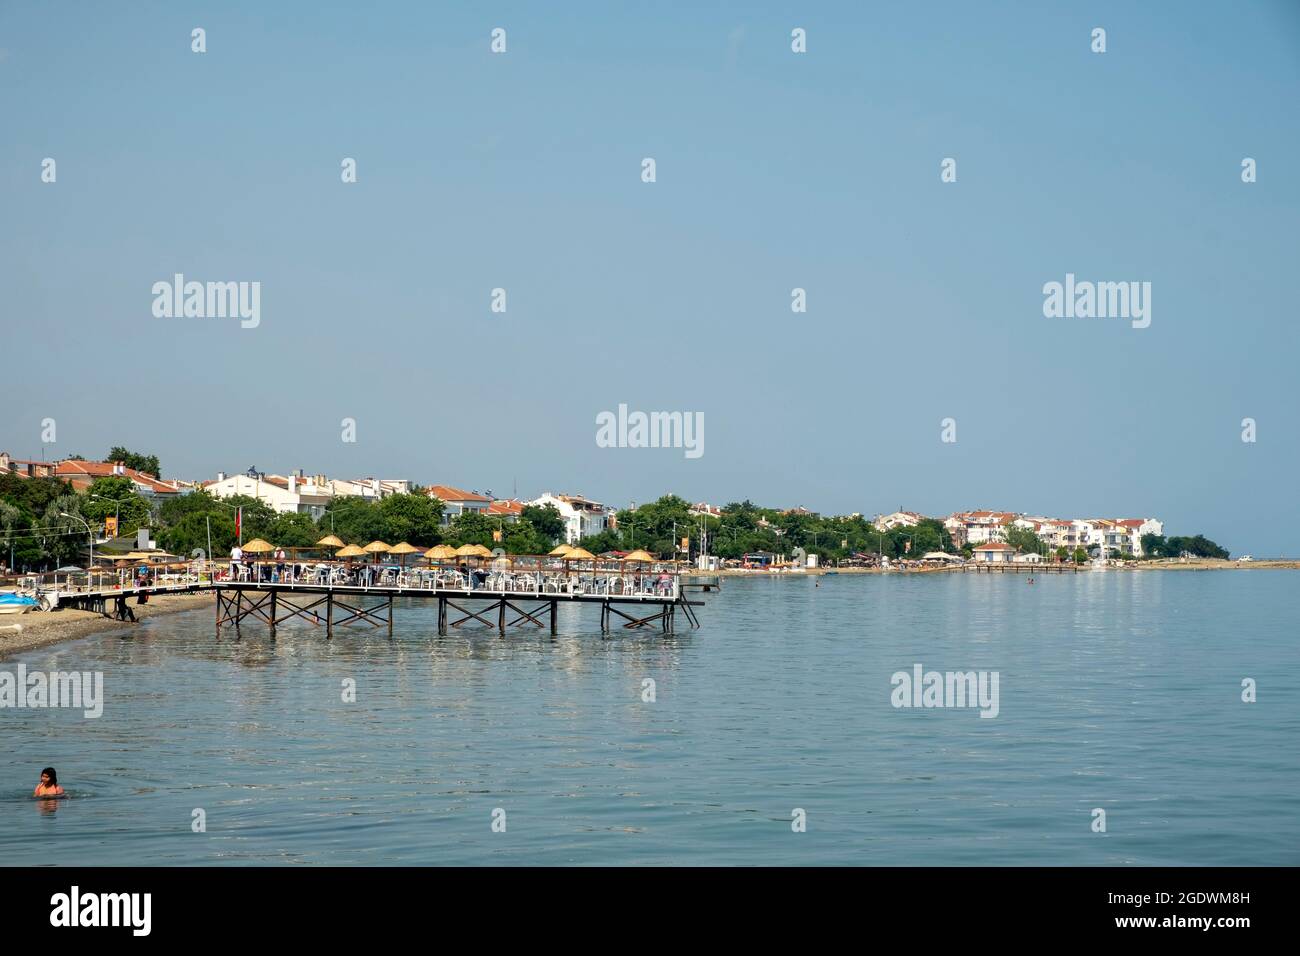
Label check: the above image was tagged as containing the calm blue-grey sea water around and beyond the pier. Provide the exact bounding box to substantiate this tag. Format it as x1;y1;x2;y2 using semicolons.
0;570;1300;865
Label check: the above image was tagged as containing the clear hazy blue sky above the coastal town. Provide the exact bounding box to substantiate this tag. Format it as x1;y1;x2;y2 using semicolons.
0;0;1300;555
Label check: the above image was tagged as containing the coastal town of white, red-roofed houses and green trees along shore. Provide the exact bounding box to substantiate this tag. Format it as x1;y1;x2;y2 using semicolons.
0;447;1229;572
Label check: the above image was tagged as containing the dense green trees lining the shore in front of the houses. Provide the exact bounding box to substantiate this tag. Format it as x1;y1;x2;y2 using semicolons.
0;447;1229;570
